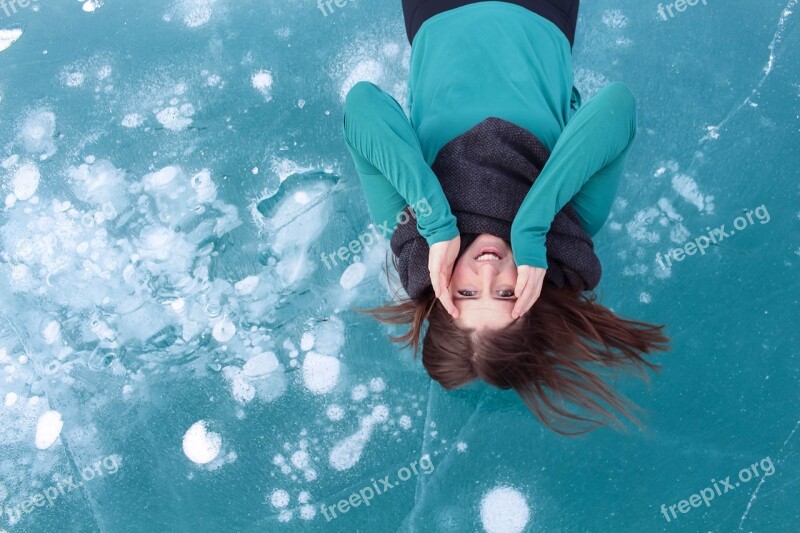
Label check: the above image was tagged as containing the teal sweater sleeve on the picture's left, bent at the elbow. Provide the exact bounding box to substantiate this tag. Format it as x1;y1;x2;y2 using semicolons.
344;81;458;245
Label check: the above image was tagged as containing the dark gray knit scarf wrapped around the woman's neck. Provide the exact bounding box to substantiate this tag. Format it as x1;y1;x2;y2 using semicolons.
390;117;602;301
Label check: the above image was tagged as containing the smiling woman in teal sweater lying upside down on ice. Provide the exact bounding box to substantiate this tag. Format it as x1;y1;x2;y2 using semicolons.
344;0;668;434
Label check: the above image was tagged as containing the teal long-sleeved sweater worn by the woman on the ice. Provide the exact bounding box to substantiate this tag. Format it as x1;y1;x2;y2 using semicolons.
344;1;636;268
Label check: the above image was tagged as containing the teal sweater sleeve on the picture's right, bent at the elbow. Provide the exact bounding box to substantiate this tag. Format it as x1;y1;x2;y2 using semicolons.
511;82;636;268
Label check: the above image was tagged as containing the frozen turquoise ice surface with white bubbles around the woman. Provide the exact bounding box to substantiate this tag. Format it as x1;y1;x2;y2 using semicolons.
0;0;800;533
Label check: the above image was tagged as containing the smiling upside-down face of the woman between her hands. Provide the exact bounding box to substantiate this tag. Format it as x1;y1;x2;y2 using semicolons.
450;233;517;330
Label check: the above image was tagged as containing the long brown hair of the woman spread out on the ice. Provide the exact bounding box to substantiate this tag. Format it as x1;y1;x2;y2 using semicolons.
358;258;669;436
